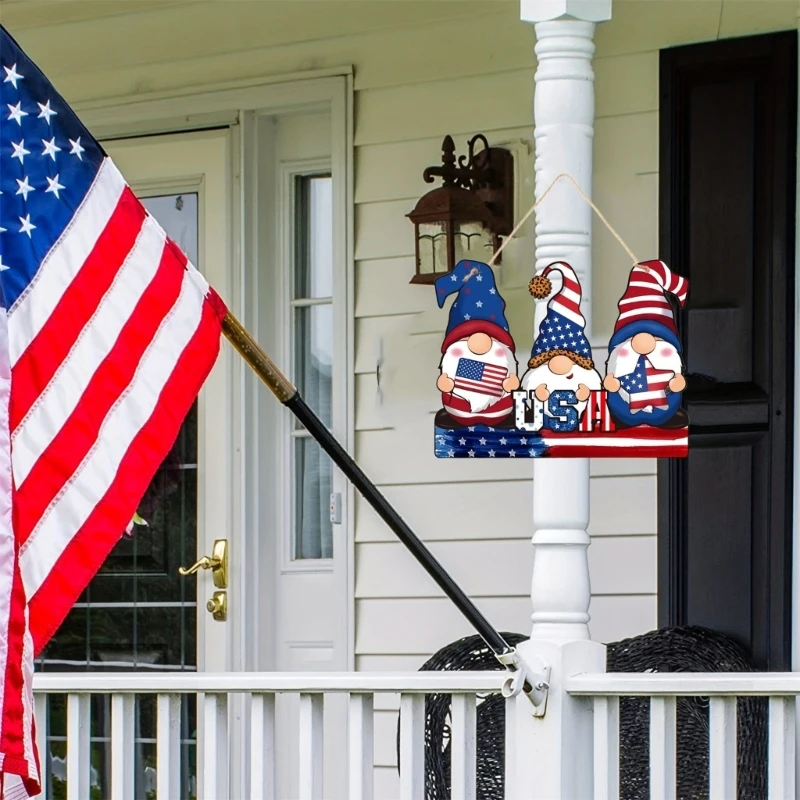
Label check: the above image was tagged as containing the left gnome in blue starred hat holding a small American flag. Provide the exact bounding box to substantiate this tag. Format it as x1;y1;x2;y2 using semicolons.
435;261;519;429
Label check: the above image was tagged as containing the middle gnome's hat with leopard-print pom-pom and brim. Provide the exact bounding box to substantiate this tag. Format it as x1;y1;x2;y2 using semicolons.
528;261;594;369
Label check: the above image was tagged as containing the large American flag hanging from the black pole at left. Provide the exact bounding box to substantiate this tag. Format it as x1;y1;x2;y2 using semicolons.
0;26;227;800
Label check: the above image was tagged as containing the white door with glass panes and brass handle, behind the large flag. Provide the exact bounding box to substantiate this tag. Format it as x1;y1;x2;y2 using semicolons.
36;130;242;800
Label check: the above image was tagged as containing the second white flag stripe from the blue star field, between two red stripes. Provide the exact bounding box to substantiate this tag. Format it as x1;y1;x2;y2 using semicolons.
11;217;165;488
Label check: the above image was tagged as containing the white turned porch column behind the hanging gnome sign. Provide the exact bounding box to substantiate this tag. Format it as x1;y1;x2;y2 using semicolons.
514;0;611;800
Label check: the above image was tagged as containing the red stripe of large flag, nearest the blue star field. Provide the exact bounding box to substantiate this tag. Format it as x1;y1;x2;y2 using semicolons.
11;188;146;431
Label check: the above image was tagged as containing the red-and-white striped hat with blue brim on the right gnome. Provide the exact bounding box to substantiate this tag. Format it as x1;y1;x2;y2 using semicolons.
608;261;689;353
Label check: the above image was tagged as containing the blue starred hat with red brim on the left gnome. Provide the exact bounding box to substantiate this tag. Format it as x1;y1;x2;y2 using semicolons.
434;261;515;353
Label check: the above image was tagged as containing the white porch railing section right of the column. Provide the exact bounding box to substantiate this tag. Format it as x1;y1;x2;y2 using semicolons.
565;672;800;800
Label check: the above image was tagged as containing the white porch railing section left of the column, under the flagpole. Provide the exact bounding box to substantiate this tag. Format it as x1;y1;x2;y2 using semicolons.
34;672;506;800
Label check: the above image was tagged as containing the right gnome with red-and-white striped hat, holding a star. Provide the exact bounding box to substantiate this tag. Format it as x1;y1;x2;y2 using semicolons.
603;261;689;428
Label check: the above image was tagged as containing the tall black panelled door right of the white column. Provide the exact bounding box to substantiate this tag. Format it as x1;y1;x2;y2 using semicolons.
658;31;797;670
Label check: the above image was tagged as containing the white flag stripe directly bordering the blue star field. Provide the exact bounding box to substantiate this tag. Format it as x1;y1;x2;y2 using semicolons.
9;159;126;367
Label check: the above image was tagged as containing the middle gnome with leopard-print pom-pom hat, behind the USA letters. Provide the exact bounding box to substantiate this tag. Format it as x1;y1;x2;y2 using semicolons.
522;261;602;430
